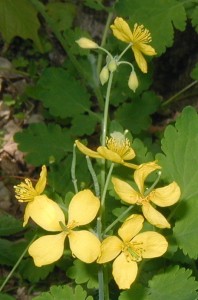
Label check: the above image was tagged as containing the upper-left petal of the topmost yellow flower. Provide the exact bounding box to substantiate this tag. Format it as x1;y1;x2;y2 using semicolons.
110;17;133;43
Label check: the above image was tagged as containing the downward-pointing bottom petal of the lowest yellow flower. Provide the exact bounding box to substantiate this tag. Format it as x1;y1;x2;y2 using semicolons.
112;253;138;289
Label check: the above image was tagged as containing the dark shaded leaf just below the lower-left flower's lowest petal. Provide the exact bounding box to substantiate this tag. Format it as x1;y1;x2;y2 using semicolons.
19;258;54;283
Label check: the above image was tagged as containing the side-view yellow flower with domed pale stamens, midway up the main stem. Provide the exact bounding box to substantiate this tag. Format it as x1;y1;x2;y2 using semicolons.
75;132;137;169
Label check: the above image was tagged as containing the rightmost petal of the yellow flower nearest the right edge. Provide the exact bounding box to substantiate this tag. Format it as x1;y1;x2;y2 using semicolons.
150;181;181;207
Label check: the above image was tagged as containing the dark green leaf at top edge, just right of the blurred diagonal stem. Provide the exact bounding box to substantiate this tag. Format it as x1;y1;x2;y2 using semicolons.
46;2;76;31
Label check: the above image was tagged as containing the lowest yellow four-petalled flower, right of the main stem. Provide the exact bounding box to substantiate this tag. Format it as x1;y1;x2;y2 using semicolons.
97;215;168;289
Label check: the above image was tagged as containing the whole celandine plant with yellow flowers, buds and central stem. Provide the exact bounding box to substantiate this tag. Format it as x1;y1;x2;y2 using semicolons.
10;18;181;300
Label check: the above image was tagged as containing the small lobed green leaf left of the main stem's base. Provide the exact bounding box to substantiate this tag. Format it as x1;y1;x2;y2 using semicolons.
67;259;98;289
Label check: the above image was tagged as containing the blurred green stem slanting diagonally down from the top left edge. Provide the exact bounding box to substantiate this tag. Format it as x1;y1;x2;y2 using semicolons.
30;0;104;108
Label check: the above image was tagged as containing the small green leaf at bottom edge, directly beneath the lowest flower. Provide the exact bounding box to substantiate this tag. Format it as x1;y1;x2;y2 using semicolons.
118;284;148;300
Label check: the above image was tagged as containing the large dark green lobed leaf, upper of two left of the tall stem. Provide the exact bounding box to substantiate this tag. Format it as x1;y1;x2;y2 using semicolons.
30;68;90;118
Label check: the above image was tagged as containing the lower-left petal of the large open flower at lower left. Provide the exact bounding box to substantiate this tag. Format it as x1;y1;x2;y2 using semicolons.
28;232;66;267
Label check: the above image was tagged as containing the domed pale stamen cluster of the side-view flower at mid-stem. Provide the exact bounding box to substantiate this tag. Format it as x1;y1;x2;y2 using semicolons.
106;132;131;157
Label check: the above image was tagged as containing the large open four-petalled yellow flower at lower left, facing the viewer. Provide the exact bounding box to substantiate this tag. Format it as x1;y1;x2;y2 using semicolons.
28;190;100;267
